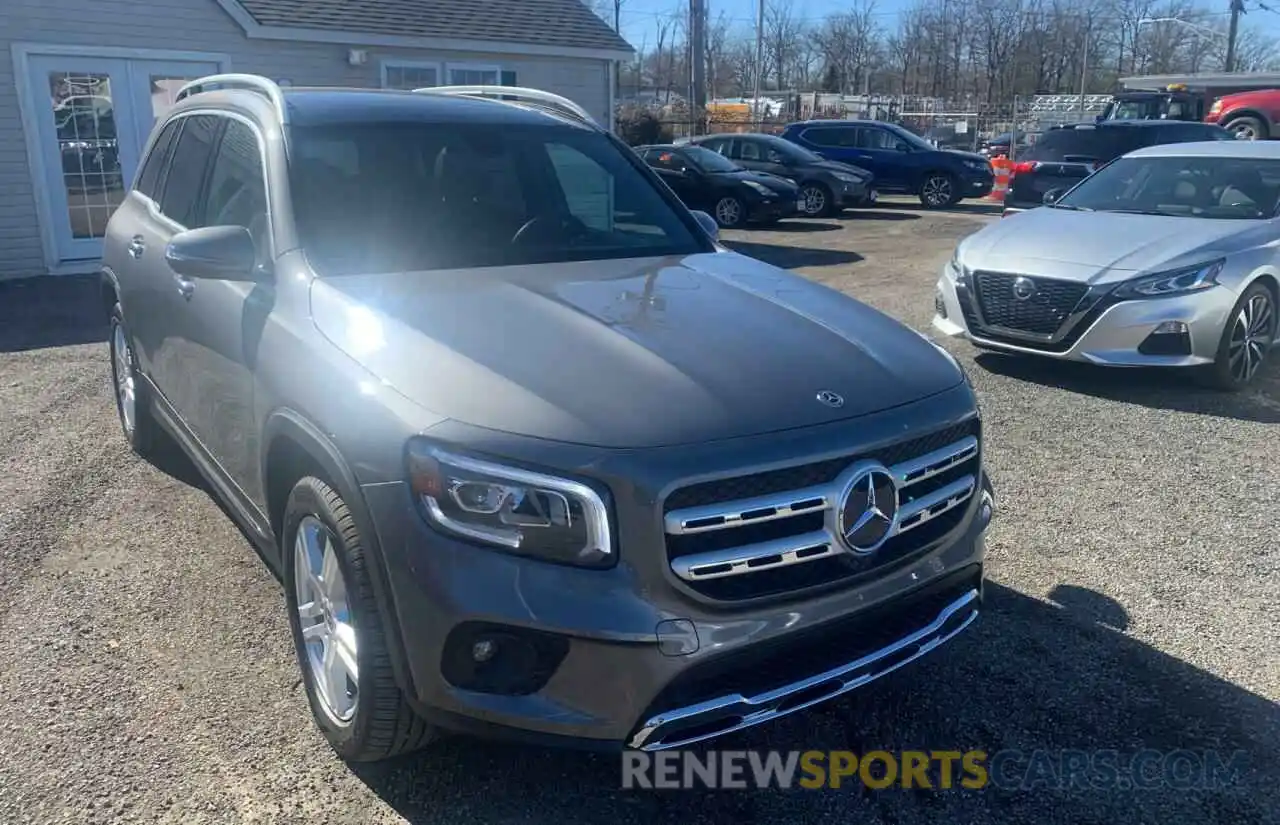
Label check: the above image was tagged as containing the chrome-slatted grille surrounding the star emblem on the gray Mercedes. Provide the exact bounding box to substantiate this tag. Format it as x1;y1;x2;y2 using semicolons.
663;420;980;600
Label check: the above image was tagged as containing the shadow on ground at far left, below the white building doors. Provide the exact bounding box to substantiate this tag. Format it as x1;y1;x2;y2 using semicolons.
0;275;108;352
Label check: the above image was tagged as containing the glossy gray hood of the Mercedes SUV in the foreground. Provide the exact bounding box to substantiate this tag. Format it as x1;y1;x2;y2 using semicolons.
311;252;963;448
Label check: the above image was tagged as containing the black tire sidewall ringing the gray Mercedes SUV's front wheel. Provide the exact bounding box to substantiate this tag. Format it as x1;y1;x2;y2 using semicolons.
280;477;378;757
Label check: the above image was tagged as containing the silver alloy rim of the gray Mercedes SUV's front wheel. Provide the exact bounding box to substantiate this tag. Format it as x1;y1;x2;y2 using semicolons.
293;515;360;725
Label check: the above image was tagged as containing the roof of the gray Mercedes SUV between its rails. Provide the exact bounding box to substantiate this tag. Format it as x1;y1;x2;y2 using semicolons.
282;87;588;129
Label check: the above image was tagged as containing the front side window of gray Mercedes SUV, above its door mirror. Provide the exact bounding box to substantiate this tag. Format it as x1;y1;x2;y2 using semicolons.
201;120;268;248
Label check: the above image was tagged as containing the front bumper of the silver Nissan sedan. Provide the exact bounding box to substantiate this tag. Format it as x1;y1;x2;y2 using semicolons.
933;265;1236;367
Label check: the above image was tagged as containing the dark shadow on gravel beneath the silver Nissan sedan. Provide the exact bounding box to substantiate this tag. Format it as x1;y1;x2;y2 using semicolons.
974;352;1280;423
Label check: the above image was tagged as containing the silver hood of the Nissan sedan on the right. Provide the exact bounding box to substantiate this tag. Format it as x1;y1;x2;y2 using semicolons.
960;207;1274;283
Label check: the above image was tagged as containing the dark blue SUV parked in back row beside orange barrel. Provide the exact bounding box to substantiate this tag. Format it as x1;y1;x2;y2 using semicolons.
782;120;995;208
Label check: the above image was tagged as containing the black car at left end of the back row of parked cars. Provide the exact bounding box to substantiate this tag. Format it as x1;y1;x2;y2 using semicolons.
635;145;800;229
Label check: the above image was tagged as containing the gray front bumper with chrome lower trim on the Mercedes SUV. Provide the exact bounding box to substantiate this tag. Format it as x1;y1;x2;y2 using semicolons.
362;404;995;750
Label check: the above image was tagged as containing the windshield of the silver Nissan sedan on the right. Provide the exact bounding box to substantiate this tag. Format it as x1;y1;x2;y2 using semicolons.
1055;156;1280;219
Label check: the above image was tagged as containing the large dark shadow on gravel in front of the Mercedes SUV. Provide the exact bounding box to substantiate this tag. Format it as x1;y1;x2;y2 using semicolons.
353;582;1280;825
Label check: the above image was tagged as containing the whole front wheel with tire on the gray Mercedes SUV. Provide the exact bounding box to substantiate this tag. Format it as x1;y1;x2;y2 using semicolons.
280;477;438;762
